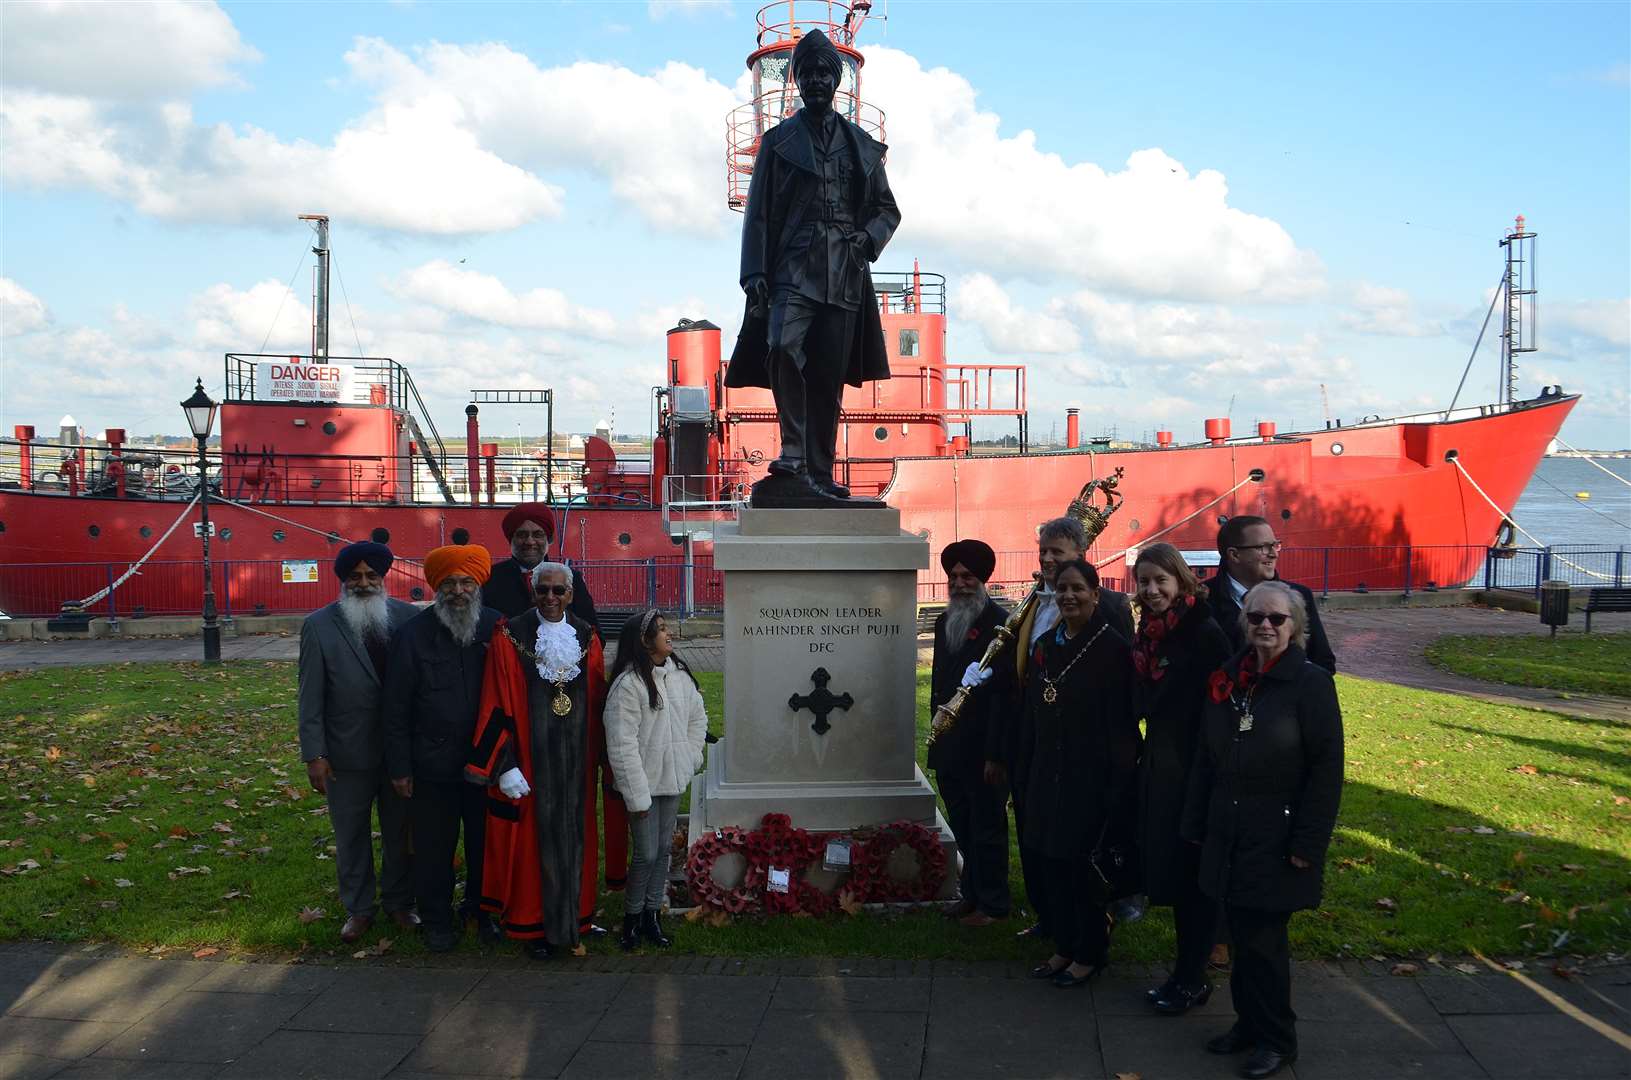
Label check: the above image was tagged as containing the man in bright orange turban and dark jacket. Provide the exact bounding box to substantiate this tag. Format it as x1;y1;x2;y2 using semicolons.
383;545;499;953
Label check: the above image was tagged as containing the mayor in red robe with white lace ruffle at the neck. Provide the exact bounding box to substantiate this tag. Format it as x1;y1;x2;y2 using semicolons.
465;563;605;959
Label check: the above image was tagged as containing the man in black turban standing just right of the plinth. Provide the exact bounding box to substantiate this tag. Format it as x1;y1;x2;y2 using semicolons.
928;540;1010;927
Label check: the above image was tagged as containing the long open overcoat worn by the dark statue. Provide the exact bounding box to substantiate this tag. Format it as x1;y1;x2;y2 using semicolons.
724;109;900;390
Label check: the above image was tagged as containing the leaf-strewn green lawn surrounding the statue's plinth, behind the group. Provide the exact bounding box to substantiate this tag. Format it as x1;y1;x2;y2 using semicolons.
0;662;1631;961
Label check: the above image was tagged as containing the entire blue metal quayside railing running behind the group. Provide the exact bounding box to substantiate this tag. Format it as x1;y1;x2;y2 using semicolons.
0;545;1631;620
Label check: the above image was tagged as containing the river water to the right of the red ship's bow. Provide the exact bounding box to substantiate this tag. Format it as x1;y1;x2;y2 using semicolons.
1512;457;1631;547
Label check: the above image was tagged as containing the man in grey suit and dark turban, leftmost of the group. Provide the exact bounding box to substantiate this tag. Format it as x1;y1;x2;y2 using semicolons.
298;540;419;945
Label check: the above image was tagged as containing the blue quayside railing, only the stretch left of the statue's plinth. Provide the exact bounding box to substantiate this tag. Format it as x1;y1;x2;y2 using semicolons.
0;553;724;622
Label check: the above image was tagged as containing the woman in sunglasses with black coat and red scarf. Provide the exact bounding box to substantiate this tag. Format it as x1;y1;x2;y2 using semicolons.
1184;581;1342;1080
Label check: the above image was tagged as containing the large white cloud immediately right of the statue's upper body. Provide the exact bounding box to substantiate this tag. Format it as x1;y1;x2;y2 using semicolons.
863;47;1323;299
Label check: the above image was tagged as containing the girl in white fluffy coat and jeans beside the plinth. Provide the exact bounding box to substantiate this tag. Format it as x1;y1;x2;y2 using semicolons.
605;610;708;949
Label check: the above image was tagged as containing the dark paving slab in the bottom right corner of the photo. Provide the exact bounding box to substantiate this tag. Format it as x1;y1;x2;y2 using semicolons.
1445;1015;1631;1080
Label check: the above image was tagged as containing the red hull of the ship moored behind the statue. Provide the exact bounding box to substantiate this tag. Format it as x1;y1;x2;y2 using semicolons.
0;396;1577;615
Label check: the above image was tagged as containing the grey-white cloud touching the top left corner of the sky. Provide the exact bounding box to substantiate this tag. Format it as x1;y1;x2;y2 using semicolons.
0;0;259;103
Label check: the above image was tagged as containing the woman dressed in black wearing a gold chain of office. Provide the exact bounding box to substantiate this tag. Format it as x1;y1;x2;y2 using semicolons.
1023;560;1138;989
